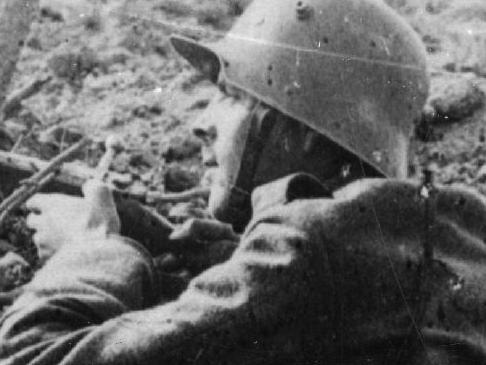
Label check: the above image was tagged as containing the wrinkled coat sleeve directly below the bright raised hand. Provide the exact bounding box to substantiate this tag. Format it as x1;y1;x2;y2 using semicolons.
0;236;156;364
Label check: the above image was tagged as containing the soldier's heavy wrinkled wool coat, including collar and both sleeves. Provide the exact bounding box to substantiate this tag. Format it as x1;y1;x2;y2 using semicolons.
0;175;486;365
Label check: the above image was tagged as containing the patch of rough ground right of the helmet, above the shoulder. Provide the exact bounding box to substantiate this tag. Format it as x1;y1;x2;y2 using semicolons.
387;0;486;192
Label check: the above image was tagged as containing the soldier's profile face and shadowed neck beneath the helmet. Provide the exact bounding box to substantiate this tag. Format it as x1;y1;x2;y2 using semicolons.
193;86;350;223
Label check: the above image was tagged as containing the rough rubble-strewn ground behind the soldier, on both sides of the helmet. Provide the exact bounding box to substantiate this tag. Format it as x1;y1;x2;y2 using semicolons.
0;0;486;191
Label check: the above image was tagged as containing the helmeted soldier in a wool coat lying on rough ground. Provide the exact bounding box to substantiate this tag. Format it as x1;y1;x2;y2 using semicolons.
0;0;486;365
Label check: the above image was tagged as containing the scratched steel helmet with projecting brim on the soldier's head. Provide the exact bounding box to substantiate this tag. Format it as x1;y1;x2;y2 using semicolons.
171;0;429;178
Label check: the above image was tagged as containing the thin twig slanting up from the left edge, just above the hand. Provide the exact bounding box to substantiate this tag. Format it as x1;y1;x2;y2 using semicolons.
0;138;90;226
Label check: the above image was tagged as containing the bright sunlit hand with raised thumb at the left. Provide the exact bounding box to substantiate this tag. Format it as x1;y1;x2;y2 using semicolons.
27;180;120;262
